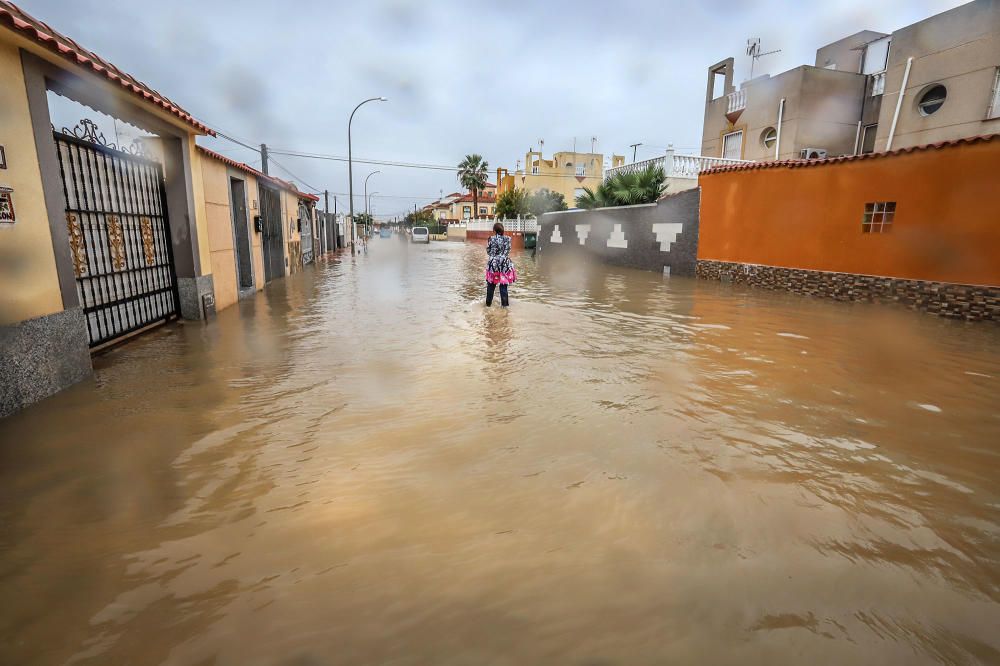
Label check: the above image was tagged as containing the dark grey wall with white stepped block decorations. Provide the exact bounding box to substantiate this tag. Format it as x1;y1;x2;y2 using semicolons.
538;189;700;276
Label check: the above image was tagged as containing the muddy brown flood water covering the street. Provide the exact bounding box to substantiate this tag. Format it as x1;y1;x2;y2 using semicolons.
0;239;1000;666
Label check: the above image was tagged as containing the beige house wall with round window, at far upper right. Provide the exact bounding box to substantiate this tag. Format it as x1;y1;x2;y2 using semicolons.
875;0;1000;151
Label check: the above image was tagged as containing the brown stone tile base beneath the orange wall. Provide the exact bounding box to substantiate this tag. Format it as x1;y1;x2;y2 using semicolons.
697;259;1000;321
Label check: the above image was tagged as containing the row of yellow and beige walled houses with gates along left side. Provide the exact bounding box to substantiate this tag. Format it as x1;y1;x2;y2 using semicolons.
0;0;317;418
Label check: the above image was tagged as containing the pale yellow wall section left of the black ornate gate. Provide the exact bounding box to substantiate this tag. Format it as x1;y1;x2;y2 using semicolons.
0;40;63;325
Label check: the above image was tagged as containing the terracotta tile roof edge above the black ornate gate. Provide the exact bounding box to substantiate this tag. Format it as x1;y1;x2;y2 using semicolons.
0;0;215;136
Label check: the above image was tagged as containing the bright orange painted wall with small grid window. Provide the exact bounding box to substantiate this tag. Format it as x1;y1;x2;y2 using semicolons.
698;135;1000;285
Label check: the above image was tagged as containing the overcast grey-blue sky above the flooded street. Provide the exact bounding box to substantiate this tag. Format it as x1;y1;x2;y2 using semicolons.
33;0;963;216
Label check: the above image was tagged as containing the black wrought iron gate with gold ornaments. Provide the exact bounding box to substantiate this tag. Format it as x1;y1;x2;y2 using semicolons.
55;132;179;347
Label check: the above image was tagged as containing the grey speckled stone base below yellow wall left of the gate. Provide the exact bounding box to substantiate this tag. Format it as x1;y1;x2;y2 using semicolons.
0;308;93;418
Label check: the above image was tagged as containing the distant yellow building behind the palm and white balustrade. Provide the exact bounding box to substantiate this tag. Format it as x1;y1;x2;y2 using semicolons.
497;150;622;208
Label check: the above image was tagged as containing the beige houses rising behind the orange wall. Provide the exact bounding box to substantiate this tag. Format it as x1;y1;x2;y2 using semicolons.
701;0;1000;161
